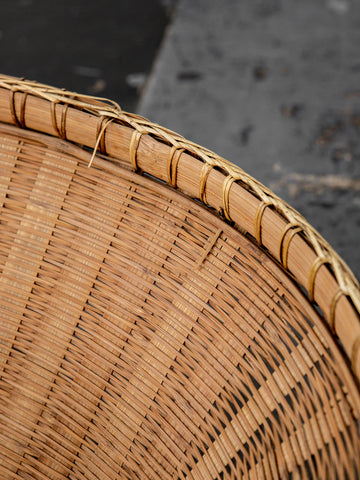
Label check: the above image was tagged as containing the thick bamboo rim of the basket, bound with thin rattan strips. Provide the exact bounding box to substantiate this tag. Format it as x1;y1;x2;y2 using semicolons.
0;75;360;381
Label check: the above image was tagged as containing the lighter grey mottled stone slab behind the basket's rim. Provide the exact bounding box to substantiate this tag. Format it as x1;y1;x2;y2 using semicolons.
138;0;360;278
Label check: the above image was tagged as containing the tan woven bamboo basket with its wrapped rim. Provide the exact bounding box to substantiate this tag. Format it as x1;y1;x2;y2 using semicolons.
0;76;360;480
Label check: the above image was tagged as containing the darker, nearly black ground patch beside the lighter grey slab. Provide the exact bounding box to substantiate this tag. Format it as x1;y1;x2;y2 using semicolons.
0;0;172;111
